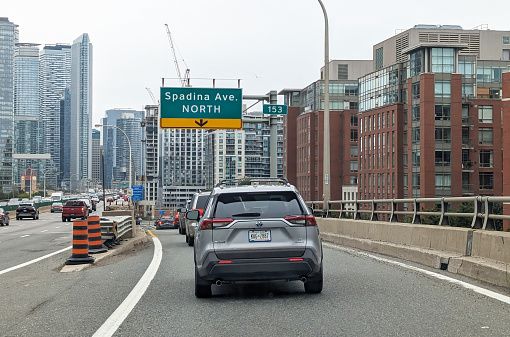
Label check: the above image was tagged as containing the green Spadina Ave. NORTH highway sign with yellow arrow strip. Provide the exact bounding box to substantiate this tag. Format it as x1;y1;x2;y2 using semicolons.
160;87;243;129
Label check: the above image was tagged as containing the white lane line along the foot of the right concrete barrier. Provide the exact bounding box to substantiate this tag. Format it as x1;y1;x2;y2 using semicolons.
323;243;510;304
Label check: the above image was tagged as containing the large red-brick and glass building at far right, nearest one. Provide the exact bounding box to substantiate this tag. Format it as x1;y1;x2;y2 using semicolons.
359;25;510;199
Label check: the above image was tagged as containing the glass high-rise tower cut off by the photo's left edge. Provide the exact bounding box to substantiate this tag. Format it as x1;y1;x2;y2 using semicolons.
0;17;18;191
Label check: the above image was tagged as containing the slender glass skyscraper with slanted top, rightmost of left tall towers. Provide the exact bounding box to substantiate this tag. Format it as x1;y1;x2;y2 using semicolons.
70;33;92;192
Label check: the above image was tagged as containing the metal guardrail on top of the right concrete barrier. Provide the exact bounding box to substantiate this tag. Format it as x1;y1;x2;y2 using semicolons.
306;196;510;230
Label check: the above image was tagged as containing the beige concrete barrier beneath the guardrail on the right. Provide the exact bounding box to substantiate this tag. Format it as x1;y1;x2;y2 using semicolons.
317;218;510;287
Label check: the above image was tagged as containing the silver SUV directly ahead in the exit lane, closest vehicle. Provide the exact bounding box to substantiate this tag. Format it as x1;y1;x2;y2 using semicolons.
186;178;323;297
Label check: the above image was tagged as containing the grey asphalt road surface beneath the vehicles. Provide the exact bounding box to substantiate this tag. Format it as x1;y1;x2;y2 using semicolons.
0;214;510;336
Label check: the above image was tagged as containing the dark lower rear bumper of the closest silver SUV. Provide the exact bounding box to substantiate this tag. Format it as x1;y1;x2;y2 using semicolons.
198;249;321;282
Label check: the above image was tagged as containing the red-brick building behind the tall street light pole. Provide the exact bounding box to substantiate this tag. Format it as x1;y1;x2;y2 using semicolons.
280;60;372;201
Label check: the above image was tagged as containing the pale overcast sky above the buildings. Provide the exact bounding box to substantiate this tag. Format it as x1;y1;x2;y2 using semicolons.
0;0;510;124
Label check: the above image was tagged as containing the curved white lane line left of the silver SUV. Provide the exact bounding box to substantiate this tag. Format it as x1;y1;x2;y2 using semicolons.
92;237;163;337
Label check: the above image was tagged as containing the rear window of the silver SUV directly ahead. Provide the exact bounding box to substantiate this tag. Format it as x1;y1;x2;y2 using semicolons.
214;191;303;218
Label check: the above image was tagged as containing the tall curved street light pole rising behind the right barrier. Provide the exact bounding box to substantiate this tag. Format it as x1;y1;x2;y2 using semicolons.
318;0;331;215
